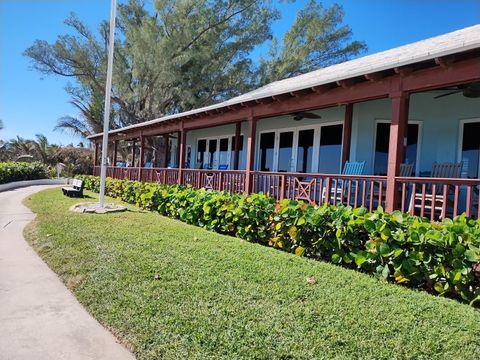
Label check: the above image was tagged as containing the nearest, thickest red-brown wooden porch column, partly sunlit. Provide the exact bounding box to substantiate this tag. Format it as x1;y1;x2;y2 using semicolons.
385;91;408;212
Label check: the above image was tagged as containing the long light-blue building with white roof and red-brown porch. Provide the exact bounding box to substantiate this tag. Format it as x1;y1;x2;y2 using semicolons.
90;25;480;220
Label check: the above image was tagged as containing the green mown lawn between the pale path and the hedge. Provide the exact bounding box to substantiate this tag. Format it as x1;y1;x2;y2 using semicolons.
26;189;480;359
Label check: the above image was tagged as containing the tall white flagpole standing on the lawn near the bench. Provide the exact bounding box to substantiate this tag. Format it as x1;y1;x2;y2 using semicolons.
100;0;116;208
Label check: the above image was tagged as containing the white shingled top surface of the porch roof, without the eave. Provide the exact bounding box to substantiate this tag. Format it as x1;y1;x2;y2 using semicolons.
88;24;480;139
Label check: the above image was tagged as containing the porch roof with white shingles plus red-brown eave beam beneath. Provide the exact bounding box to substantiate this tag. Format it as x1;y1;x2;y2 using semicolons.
89;25;480;141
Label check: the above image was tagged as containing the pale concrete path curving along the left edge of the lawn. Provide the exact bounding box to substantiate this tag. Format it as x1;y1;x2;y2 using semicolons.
0;186;134;360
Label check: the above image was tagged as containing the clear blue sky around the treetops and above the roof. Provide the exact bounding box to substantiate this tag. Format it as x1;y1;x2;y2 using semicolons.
0;0;480;144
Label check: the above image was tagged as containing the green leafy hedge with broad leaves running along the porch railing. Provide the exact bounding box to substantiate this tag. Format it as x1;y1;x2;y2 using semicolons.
81;176;480;305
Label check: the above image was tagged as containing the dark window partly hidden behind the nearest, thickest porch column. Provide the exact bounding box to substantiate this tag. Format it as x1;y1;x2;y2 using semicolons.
373;122;420;175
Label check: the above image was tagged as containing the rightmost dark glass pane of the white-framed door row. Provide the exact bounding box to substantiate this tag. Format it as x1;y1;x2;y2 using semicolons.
318;124;343;174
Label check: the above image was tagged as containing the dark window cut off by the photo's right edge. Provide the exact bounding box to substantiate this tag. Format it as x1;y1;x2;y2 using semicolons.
460;121;480;179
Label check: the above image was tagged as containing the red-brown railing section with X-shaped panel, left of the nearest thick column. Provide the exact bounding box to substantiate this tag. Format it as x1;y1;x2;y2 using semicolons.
253;172;387;211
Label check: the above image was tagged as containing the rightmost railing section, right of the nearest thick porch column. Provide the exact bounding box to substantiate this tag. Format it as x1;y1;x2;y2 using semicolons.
395;177;480;221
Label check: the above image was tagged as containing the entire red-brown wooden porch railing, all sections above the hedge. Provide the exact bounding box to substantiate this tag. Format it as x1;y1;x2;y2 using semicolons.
94;166;480;221
